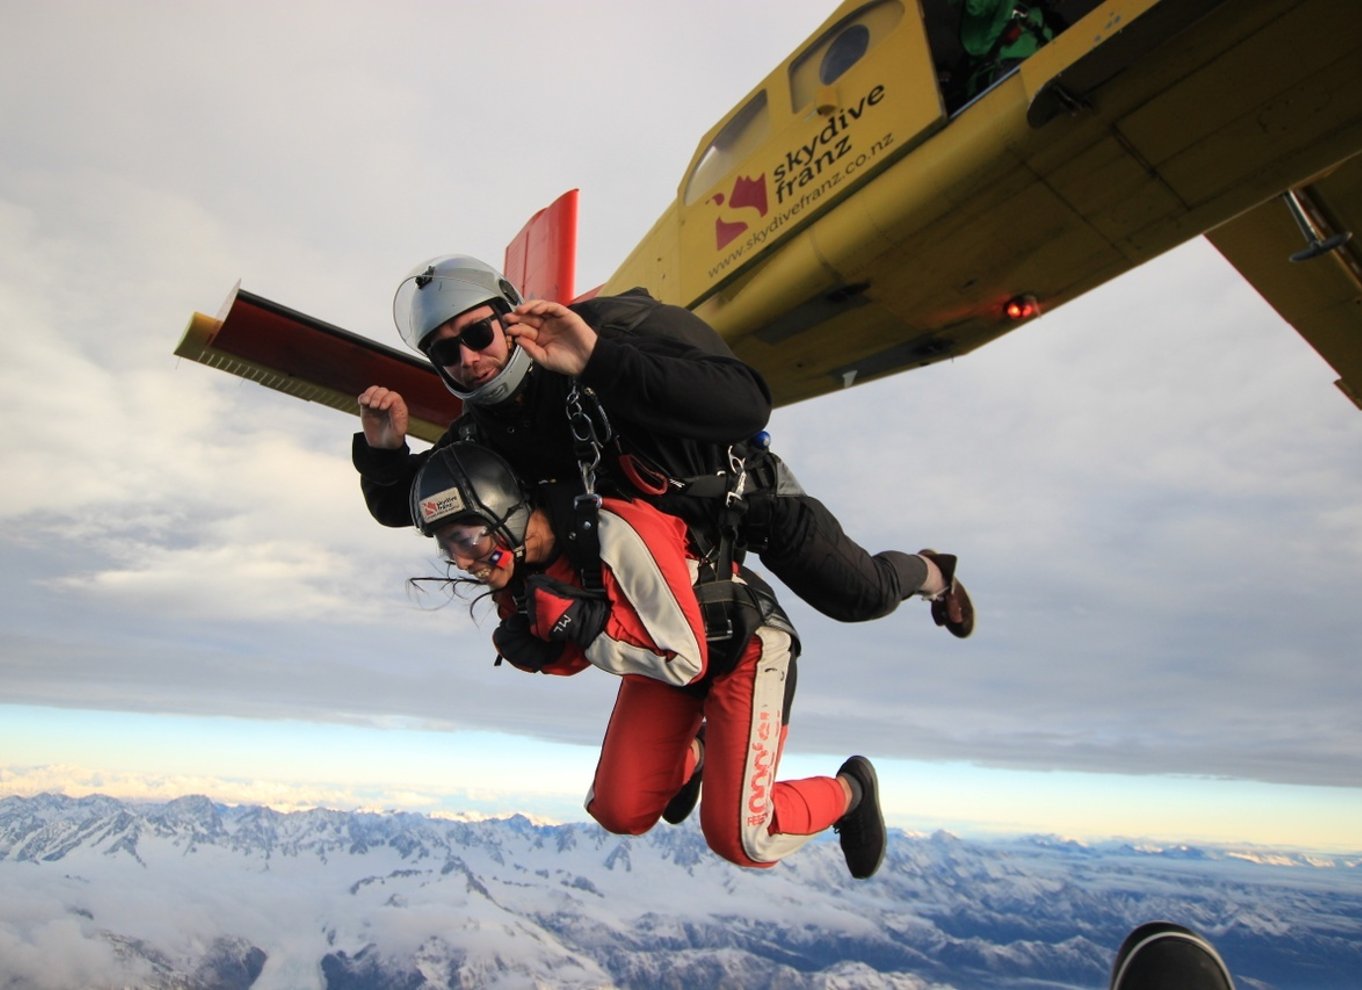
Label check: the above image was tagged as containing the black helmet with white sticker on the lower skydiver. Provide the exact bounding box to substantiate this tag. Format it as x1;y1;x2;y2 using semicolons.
411;441;530;557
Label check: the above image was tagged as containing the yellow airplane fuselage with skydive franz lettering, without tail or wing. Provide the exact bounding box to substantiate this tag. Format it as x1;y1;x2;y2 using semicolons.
602;0;1362;402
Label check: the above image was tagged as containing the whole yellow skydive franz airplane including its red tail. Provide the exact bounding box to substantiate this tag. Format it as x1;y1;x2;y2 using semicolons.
176;0;1362;440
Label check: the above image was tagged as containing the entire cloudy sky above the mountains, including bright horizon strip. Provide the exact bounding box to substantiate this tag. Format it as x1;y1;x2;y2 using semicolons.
0;0;1362;848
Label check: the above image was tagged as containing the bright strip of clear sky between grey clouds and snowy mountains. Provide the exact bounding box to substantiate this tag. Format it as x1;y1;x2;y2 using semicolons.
10;707;1362;852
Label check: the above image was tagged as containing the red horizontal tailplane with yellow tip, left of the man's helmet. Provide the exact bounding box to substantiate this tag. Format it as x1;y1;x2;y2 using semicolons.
174;286;459;443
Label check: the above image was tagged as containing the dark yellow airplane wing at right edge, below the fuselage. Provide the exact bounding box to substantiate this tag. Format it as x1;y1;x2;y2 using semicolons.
1207;155;1362;409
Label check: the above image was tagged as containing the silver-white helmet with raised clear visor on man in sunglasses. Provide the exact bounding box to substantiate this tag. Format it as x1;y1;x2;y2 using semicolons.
392;255;534;406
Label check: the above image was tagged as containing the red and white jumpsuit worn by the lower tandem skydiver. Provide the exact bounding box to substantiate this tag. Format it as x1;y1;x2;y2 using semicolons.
503;498;846;867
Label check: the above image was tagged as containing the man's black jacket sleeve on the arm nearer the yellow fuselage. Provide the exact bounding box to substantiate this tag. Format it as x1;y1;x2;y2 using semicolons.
579;300;771;443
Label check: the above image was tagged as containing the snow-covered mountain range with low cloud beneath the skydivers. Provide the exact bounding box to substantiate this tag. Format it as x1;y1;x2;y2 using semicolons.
0;795;1362;990
